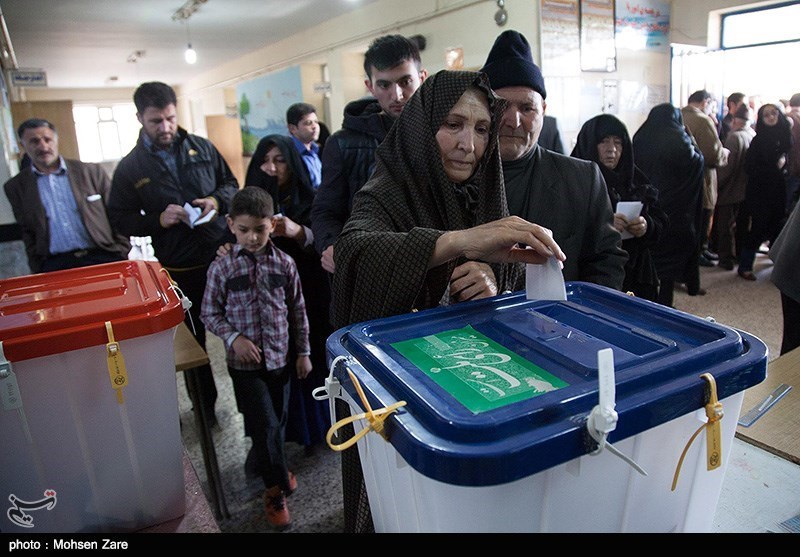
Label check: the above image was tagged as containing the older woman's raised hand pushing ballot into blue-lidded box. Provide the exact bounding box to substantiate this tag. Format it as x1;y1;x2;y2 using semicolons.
428;216;567;268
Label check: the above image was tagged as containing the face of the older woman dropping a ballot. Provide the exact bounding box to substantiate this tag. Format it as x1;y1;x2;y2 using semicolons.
436;88;492;183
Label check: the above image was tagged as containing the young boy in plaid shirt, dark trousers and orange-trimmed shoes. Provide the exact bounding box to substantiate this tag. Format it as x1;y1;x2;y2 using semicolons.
201;187;311;529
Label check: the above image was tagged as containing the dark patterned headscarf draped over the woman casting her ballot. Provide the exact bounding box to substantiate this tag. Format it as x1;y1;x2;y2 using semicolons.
334;70;524;327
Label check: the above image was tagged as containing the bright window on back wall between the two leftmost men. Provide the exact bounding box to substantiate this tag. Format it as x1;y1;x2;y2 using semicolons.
72;103;140;162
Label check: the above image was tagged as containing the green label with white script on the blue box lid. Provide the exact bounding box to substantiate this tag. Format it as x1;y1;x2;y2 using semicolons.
392;326;569;414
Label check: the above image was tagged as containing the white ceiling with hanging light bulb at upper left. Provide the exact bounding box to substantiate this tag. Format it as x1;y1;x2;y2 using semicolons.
0;0;377;88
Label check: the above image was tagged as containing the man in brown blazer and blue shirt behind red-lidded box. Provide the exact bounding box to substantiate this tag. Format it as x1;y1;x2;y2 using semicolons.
4;118;130;273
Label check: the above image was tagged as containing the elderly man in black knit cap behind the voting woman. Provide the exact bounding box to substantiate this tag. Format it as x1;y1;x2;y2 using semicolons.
482;30;628;289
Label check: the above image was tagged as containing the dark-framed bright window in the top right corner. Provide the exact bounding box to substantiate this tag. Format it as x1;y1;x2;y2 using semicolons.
721;2;800;48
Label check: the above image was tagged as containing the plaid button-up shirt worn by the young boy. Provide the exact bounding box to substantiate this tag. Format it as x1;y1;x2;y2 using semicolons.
200;242;311;370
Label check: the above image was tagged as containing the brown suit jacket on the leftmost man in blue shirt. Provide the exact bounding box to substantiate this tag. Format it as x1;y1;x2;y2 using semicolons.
3;159;130;273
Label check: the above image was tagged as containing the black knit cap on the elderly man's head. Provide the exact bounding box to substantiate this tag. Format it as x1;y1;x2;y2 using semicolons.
481;30;547;99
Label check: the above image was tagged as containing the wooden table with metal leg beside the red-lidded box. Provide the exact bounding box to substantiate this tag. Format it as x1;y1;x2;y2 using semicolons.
175;323;230;519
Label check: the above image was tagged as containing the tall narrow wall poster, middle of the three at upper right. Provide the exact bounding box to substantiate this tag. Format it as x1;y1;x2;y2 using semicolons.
580;0;617;72
